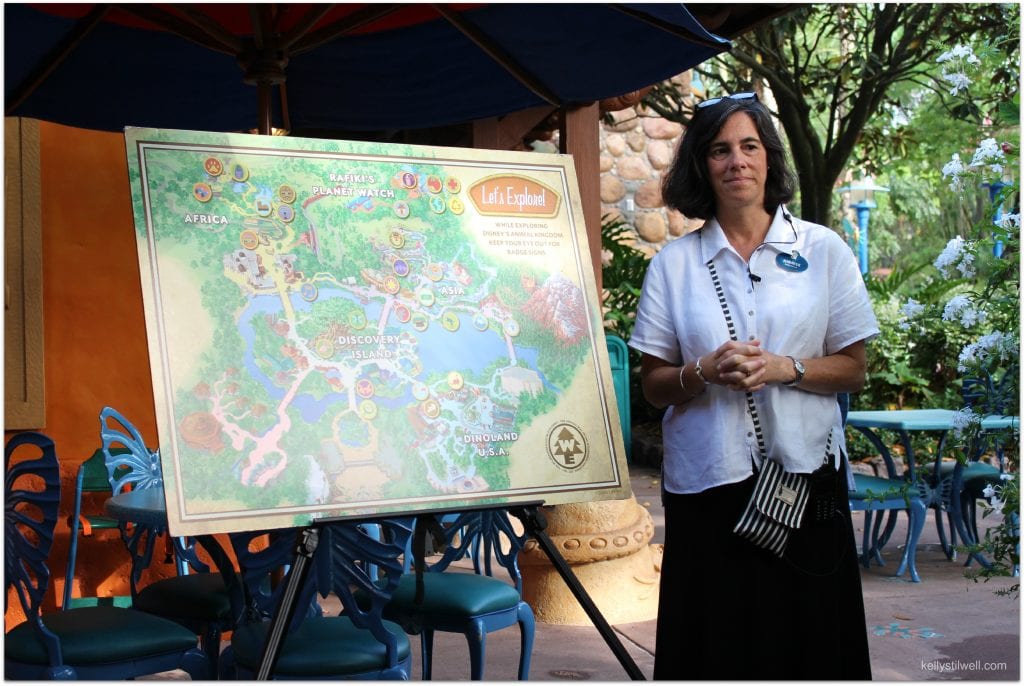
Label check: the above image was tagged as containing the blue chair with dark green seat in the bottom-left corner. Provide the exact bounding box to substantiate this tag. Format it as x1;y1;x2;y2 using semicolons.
4;432;209;680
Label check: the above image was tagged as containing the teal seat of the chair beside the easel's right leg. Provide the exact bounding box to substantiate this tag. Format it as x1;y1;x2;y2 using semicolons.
384;571;520;617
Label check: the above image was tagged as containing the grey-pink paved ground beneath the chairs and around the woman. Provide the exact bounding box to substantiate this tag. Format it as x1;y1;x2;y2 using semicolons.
144;467;1020;682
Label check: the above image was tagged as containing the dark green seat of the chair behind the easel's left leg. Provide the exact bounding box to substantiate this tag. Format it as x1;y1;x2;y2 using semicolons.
231;616;412;679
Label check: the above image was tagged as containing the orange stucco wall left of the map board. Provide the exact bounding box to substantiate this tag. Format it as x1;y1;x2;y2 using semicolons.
5;122;173;627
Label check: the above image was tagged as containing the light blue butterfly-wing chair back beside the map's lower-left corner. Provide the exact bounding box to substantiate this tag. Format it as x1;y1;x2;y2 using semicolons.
99;408;164;496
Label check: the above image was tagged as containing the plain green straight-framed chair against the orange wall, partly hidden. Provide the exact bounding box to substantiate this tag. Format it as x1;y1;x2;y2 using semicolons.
60;448;131;609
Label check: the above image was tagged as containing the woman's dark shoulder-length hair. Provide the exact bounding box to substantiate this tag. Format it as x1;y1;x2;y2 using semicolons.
662;97;796;219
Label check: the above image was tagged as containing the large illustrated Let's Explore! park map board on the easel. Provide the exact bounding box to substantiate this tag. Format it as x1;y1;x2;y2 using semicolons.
125;128;631;535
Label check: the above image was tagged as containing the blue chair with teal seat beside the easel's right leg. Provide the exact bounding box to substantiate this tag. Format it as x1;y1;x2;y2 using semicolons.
384;510;535;681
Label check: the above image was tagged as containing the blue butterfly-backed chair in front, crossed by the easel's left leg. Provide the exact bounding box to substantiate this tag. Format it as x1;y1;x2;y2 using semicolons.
220;517;413;681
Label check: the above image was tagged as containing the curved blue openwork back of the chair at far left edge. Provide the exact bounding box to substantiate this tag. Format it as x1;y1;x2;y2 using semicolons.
4;431;62;664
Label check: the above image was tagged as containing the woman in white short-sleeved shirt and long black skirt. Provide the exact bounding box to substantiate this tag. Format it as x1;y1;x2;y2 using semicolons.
630;93;879;680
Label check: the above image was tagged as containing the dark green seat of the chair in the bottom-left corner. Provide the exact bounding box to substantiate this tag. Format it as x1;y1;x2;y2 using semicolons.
4;607;197;666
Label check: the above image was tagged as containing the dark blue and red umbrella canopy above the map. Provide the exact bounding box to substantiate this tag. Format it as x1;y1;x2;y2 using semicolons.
4;3;730;132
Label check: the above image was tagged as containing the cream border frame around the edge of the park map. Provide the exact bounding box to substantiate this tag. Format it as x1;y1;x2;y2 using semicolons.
125;127;632;535
